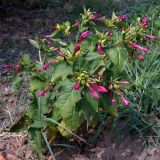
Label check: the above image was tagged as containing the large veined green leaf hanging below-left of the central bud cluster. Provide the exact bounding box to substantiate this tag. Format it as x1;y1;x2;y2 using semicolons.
55;80;81;118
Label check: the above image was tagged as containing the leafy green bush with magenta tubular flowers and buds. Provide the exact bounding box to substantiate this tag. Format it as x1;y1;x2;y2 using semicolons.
2;9;158;153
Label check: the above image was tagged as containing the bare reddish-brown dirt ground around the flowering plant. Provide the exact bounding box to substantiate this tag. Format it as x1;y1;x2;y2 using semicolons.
0;3;160;160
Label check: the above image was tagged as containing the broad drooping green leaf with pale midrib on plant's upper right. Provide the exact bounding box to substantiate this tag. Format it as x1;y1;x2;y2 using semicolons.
109;46;128;74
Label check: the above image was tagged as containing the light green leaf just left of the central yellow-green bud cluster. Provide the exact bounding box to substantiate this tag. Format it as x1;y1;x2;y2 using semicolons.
51;62;72;82
